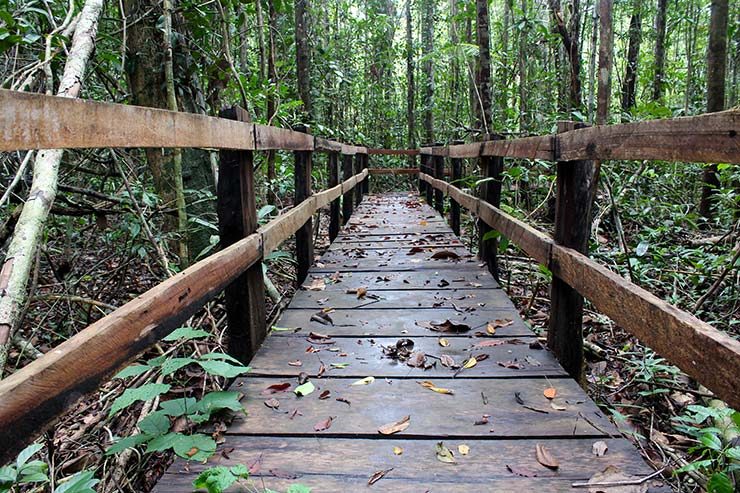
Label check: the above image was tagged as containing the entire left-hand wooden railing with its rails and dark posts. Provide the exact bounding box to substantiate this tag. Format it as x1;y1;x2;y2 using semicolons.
0;90;369;464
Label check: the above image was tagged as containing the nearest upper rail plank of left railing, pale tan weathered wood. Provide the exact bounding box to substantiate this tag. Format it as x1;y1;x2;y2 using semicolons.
0;89;254;151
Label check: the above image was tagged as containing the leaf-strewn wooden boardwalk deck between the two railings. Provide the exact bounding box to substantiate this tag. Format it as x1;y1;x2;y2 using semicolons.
155;193;653;493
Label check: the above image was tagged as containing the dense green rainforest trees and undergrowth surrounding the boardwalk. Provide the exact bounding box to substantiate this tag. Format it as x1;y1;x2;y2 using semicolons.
0;0;740;492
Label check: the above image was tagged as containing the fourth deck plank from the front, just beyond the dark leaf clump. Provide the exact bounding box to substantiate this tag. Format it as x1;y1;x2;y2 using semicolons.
275;306;532;338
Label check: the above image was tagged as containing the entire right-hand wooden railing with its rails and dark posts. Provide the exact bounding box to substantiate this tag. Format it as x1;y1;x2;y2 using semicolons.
419;110;740;409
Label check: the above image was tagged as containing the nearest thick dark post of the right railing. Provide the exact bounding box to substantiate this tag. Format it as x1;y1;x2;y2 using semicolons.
547;122;594;381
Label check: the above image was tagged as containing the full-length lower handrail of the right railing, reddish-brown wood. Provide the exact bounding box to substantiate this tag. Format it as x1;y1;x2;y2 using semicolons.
420;173;740;409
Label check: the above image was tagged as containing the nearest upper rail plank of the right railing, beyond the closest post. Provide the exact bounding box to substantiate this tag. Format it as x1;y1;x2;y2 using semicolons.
557;109;740;164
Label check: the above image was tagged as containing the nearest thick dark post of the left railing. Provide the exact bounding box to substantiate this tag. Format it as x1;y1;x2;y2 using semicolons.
216;106;267;363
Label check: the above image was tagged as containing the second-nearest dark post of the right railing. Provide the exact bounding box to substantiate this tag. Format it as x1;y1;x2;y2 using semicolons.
478;135;504;280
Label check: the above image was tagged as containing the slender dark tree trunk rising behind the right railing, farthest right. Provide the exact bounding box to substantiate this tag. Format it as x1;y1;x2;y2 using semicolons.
699;0;728;220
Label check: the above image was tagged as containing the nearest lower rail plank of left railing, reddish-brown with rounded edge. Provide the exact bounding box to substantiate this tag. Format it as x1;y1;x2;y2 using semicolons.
0;234;261;464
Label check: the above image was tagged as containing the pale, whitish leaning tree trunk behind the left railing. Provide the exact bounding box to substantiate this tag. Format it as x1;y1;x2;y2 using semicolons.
0;0;103;375
